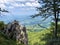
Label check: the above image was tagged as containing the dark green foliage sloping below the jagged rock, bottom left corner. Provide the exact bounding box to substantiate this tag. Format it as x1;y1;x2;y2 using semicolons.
0;32;23;45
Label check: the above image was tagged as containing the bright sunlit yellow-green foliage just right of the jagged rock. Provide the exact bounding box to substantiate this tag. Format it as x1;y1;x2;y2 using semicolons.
28;30;50;45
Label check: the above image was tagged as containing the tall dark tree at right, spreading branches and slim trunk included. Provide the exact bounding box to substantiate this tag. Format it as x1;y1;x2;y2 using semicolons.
31;0;60;38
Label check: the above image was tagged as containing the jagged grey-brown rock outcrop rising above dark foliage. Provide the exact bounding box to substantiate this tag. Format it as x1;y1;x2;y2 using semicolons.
4;20;28;45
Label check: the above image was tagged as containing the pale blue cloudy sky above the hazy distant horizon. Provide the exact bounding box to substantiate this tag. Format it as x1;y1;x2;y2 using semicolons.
0;0;40;15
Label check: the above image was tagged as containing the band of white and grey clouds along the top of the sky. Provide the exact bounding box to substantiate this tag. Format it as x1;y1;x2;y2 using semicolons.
0;0;40;8
